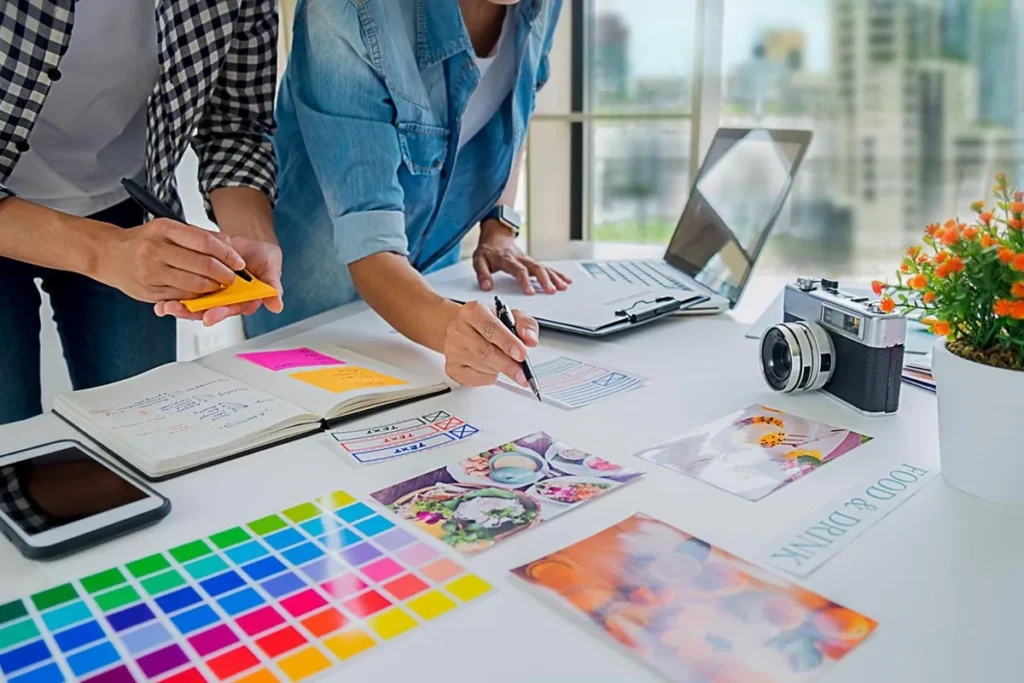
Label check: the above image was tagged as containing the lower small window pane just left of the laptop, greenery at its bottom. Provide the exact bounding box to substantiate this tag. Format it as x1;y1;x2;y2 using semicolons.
591;121;690;244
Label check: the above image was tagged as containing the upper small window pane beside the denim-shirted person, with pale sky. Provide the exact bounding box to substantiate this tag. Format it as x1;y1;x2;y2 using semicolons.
587;0;696;113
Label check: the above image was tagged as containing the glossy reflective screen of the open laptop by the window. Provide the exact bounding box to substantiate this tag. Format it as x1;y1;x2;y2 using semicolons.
666;129;811;305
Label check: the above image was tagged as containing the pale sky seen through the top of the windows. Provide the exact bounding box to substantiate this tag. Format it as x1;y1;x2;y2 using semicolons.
593;0;831;76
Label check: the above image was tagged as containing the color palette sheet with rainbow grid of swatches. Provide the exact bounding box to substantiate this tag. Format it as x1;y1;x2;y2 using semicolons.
0;492;493;683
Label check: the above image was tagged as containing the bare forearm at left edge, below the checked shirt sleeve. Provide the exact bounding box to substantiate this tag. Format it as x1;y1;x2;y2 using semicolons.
0;197;112;278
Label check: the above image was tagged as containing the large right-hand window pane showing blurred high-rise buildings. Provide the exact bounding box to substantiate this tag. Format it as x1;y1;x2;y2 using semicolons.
720;0;1024;280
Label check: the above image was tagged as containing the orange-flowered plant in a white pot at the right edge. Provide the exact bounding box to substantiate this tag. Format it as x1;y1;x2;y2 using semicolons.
872;173;1024;503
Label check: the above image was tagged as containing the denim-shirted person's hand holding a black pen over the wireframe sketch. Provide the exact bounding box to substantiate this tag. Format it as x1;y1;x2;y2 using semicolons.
443;301;539;387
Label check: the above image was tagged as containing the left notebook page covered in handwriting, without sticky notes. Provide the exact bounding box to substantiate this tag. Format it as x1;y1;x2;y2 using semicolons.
55;362;313;463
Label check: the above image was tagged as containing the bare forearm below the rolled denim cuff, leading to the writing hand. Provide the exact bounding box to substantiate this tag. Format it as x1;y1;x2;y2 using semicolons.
349;252;459;353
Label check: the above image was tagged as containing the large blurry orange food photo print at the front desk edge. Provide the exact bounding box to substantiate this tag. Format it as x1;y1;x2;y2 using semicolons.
513;514;877;683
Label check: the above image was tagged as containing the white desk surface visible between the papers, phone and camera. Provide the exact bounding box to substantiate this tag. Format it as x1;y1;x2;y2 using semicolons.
0;259;1024;683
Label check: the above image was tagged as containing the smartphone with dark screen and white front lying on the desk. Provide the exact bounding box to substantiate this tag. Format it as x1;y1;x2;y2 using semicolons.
0;439;171;560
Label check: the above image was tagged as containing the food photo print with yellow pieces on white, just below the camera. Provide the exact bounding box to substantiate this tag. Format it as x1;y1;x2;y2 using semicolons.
637;405;871;501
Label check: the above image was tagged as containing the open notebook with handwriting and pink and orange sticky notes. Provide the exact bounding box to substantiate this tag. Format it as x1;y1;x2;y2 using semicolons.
53;343;449;480
